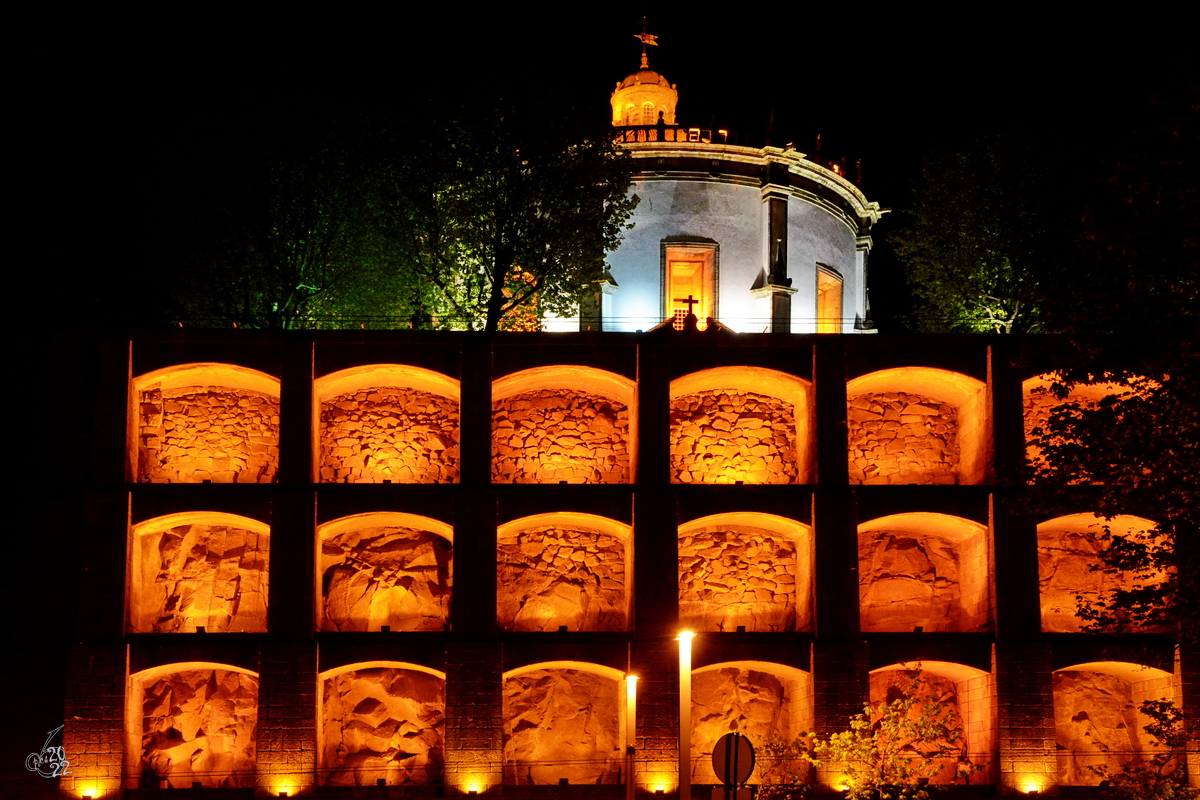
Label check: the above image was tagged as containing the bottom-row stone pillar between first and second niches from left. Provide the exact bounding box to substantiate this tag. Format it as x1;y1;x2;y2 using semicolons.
254;643;318;796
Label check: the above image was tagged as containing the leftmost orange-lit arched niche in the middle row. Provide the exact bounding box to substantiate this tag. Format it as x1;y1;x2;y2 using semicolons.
126;511;271;633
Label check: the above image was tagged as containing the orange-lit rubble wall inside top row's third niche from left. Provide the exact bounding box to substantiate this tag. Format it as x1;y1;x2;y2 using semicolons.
492;389;630;483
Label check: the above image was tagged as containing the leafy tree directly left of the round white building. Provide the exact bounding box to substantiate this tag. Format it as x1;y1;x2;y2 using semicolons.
389;98;637;331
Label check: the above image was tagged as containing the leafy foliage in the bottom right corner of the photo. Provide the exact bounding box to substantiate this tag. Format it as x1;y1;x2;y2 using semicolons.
1090;700;1200;800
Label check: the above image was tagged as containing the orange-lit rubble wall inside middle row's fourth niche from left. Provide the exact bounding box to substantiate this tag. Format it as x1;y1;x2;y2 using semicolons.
679;525;806;632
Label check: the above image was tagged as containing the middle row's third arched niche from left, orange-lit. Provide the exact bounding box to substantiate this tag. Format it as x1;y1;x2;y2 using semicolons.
496;511;634;631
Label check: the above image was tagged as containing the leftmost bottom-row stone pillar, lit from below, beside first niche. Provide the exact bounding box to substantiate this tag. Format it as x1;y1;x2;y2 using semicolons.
60;644;126;796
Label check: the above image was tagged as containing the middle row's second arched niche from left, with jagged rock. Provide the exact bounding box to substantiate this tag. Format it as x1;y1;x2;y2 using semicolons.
317;512;454;631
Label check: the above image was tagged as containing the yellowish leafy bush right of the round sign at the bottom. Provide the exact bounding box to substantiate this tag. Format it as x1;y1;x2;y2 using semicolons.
757;667;979;800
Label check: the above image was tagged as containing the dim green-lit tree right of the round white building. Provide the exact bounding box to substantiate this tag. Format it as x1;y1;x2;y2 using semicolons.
888;139;1062;333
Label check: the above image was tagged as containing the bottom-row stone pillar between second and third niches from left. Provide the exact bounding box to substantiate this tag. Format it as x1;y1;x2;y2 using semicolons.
445;642;504;794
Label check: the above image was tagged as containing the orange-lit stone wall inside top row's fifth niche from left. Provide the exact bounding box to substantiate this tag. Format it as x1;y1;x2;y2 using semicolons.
847;392;959;485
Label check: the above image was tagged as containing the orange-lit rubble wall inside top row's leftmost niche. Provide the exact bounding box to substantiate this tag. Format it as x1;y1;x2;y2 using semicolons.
136;386;280;483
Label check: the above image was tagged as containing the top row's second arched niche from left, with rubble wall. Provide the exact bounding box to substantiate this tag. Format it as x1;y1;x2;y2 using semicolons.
313;363;460;483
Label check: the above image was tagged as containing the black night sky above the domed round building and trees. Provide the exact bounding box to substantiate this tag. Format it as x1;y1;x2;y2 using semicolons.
65;6;1195;326
